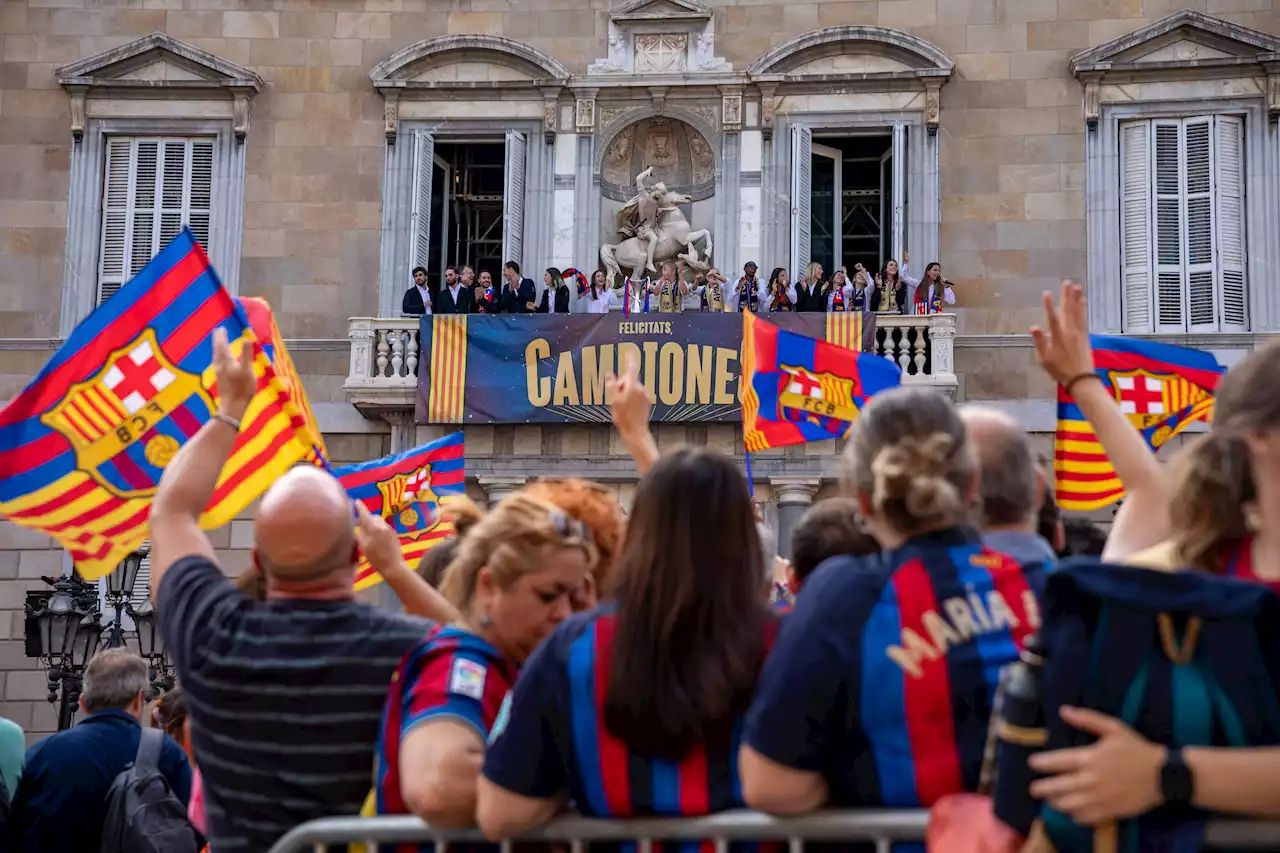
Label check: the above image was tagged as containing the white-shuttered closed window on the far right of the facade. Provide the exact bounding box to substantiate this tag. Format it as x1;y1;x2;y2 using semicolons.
1120;115;1248;333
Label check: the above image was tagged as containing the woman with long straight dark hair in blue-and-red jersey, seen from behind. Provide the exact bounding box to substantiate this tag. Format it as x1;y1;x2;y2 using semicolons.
476;448;776;839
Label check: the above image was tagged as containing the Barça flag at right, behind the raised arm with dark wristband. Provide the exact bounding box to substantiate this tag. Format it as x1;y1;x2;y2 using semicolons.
1053;336;1226;511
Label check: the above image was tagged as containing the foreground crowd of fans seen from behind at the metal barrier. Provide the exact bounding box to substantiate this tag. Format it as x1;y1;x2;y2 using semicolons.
0;280;1280;853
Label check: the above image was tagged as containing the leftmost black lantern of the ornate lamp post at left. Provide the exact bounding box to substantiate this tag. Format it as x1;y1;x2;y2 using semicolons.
26;574;102;730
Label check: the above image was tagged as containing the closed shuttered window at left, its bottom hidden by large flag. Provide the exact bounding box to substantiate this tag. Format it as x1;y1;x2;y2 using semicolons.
97;137;215;305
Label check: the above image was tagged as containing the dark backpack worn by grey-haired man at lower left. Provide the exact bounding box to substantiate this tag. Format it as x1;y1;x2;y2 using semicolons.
99;729;201;853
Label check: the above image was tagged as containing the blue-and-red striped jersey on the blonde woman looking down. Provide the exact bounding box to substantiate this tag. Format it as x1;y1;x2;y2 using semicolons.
375;625;517;853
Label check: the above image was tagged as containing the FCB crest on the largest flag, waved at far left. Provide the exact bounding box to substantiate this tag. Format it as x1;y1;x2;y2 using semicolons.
40;328;214;498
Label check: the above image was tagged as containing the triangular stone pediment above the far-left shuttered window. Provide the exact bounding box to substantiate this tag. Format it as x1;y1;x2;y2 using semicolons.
55;32;264;142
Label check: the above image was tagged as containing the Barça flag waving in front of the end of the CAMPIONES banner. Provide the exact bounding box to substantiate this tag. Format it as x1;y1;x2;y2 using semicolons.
742;311;902;452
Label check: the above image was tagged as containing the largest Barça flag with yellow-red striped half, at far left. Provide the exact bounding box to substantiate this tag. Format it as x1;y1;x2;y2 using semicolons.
0;231;311;580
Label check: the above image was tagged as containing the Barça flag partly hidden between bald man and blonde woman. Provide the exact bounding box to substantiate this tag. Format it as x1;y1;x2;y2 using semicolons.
333;433;466;589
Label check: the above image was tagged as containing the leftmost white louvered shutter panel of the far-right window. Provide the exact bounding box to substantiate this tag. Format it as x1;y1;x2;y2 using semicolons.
1120;122;1151;333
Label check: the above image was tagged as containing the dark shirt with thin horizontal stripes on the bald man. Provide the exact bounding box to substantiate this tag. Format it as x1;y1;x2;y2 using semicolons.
156;557;431;853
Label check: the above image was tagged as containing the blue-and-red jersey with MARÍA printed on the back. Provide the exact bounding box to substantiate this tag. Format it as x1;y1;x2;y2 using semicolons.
745;529;1044;808
